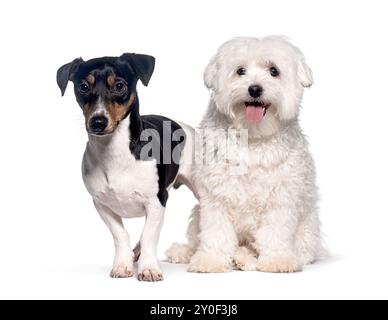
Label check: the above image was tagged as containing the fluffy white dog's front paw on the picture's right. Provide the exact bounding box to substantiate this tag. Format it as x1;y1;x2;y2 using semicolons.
257;255;302;273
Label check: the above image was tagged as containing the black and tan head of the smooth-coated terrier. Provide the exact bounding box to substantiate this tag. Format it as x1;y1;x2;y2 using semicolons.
57;53;155;135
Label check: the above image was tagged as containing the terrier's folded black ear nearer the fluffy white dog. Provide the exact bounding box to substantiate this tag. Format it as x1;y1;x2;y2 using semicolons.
120;53;155;86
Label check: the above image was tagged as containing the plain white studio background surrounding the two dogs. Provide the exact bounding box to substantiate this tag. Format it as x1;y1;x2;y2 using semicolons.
0;0;388;299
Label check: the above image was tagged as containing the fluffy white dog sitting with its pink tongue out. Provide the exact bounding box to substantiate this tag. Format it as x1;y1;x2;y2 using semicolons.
166;36;323;272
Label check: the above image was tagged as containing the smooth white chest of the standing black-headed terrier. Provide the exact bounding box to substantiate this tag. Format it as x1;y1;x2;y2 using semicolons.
82;121;158;218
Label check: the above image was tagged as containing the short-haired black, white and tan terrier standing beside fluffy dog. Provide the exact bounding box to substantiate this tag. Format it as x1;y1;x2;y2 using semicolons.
57;53;197;281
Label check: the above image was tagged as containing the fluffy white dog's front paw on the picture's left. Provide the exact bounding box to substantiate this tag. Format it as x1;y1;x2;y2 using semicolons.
188;251;232;273
